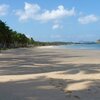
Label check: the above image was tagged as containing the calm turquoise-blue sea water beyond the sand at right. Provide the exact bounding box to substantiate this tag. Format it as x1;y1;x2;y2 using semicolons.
59;44;100;50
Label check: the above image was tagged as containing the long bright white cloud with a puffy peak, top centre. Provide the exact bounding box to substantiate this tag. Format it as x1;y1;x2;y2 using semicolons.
39;5;75;21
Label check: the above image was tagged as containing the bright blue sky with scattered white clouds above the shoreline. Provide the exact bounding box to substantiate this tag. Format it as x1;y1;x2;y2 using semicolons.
0;0;100;42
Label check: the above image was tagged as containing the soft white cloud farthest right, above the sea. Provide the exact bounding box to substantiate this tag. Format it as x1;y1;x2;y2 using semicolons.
78;14;98;24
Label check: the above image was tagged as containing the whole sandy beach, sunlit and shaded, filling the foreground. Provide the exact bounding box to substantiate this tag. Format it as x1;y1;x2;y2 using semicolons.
0;46;100;100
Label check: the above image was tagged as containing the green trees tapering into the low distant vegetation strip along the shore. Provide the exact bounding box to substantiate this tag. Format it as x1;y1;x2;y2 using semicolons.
0;20;72;49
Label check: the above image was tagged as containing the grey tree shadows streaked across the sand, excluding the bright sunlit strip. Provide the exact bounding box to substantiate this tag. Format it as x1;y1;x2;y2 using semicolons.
0;49;100;100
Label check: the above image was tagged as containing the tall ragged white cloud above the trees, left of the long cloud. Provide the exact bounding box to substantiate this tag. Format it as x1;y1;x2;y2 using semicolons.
15;2;40;21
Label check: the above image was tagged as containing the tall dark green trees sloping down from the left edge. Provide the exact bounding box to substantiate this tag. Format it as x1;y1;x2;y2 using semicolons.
0;20;35;48
